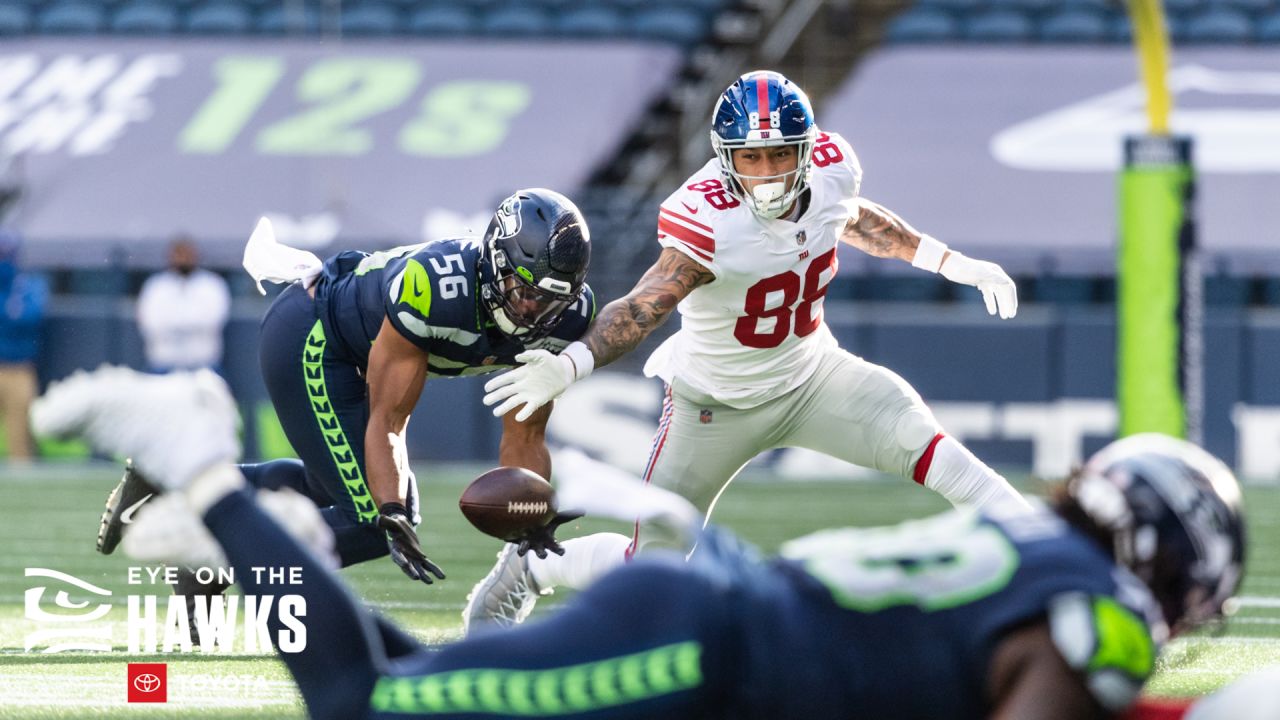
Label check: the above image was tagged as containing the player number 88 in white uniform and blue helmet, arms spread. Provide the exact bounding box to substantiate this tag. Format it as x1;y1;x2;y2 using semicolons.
466;70;1024;625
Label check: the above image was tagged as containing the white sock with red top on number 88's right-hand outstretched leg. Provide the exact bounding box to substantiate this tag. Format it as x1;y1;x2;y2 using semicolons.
914;433;1030;511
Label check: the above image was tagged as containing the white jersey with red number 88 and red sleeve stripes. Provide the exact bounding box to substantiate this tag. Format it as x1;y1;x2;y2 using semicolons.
645;133;863;409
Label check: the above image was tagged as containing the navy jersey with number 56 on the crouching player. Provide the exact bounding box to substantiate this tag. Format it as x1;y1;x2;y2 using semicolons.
316;238;595;377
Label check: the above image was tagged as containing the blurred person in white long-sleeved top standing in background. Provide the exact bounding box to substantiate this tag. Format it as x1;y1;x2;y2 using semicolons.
138;236;232;373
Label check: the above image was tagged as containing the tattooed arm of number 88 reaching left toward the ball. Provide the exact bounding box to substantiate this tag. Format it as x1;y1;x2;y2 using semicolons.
582;250;716;368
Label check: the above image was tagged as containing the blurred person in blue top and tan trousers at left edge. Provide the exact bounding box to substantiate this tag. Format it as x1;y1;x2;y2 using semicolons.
0;231;49;461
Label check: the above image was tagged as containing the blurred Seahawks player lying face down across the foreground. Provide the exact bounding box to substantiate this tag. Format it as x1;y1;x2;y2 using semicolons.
32;368;1244;720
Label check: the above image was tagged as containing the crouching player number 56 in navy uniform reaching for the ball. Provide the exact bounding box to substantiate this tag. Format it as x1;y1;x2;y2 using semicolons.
99;188;595;597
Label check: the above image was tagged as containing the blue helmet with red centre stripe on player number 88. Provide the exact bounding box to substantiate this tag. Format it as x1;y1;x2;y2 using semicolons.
712;70;818;219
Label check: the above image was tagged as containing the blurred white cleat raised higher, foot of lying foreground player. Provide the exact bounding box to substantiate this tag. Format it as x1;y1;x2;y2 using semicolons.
31;365;241;489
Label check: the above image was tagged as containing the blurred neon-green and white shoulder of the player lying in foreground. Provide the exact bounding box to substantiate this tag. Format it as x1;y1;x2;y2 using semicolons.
1048;593;1156;712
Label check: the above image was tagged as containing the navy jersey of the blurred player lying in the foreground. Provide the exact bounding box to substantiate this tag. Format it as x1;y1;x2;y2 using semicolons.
728;511;1165;719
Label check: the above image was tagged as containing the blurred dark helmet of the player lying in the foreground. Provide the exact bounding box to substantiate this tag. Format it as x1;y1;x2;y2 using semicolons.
1066;433;1244;632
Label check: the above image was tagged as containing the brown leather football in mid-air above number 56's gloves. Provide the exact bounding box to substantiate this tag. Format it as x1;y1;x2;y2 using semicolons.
458;468;556;541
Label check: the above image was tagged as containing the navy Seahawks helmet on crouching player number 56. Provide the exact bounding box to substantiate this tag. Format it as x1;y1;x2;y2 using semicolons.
480;187;591;343
